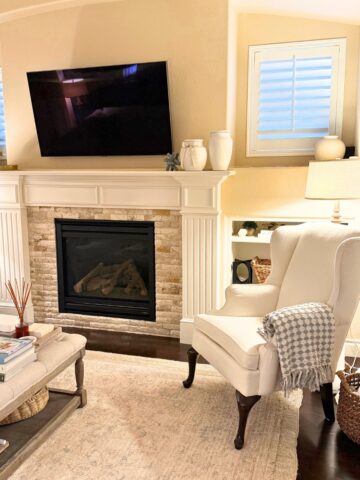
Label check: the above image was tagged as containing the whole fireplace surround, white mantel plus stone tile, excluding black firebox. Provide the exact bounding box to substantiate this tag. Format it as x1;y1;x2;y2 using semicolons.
0;170;232;343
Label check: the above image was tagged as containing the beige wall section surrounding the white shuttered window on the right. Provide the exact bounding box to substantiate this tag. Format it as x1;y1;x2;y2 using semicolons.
235;14;360;166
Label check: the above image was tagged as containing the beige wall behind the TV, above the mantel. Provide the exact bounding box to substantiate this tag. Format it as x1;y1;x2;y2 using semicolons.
0;0;228;168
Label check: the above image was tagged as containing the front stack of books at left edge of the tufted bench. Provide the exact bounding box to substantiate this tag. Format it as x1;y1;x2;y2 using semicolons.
0;337;36;382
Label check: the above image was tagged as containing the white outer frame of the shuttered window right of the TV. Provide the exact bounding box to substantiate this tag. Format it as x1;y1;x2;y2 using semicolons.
246;38;346;157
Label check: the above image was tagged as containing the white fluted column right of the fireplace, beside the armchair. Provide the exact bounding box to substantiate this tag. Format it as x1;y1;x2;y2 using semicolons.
176;171;232;343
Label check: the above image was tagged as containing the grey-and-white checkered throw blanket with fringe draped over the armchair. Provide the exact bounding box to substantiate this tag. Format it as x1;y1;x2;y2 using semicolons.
258;303;335;396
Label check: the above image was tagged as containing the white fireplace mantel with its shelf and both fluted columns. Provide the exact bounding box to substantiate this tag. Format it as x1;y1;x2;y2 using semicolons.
0;170;234;343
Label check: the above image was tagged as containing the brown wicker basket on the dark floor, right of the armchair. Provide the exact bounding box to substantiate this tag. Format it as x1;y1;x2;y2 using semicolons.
337;371;360;444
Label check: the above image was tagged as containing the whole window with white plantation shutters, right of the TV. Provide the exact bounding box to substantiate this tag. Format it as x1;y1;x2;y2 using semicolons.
247;39;346;156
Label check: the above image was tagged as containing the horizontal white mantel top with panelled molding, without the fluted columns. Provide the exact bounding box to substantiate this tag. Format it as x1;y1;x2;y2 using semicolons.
0;170;233;214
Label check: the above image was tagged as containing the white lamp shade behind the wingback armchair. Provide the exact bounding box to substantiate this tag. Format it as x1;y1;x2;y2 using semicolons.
305;159;360;200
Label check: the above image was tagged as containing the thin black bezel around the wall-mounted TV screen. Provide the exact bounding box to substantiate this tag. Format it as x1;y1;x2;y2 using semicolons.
26;60;173;158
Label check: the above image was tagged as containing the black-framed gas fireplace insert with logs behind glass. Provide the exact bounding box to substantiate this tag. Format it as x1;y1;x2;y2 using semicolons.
55;219;155;321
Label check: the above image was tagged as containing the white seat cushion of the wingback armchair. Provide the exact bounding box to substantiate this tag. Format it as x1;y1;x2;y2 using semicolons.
195;315;266;370
